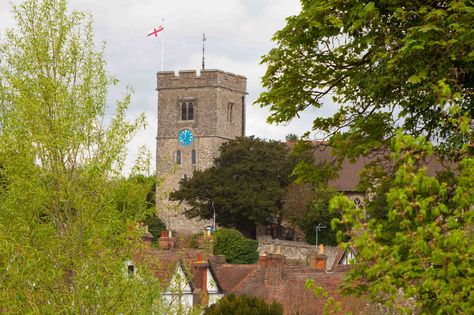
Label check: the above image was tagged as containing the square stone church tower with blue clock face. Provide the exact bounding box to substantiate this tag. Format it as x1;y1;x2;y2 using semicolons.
156;70;247;234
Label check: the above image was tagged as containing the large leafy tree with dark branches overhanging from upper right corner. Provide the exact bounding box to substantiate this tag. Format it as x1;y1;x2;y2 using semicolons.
257;0;474;159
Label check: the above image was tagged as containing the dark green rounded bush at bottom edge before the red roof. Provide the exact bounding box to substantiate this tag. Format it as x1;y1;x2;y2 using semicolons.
204;293;283;315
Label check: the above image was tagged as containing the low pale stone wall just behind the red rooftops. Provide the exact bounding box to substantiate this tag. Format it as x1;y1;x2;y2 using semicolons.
258;237;339;270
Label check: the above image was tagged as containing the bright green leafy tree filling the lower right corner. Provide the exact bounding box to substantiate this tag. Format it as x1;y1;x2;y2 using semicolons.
331;133;474;314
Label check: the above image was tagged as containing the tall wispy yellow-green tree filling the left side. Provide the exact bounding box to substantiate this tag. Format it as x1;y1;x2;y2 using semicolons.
0;0;159;314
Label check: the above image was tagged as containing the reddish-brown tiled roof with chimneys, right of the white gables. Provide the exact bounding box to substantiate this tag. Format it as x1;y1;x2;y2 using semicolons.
209;248;383;315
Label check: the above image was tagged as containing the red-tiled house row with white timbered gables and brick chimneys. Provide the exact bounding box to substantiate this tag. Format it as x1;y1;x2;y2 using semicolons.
135;233;383;315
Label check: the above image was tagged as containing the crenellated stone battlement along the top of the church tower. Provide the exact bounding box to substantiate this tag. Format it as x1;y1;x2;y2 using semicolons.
157;69;247;94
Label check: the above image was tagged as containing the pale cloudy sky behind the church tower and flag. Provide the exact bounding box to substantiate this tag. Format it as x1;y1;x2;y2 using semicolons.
0;0;334;173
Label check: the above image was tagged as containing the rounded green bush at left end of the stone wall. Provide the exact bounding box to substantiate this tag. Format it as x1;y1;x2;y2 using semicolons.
213;229;258;264
